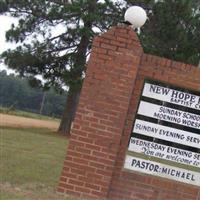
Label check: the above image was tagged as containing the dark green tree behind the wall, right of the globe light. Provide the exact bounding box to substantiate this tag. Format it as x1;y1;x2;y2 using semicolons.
140;0;200;66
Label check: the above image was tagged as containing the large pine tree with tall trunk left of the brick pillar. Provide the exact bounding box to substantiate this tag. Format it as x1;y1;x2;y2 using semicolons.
2;0;123;133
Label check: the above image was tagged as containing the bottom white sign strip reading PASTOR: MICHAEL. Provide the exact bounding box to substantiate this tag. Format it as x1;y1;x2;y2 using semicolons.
124;155;200;186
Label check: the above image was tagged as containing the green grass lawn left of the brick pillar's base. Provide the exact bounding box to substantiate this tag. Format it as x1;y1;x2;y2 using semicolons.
0;127;81;200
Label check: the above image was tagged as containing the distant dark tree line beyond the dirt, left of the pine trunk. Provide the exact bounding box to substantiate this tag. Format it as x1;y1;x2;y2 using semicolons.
0;70;66;118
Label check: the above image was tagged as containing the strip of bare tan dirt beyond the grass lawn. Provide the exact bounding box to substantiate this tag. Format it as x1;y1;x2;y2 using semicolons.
0;113;59;131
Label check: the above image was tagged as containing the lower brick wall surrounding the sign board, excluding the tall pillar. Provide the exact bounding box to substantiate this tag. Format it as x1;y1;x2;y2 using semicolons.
109;54;200;200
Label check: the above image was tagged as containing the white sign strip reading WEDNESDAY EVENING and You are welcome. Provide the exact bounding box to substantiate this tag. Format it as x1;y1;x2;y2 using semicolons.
128;137;200;167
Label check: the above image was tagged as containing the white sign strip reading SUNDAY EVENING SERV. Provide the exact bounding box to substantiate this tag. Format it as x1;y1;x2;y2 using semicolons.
133;119;200;148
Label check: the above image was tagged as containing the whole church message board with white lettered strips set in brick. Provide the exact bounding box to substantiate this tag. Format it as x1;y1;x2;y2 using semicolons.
124;80;200;186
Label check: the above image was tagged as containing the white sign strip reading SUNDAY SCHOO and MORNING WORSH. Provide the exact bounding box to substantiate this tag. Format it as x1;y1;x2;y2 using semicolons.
138;101;200;130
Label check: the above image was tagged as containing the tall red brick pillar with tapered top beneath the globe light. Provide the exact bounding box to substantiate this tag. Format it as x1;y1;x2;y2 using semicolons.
58;26;143;199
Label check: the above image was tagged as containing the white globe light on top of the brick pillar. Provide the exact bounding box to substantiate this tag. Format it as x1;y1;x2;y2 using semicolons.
124;6;147;28
